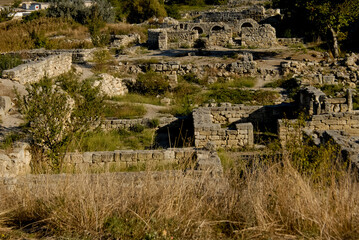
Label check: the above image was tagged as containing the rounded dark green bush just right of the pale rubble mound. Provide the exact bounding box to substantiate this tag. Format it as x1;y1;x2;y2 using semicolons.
130;71;170;96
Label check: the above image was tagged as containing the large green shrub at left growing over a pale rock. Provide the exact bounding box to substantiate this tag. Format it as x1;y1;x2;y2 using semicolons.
17;74;102;172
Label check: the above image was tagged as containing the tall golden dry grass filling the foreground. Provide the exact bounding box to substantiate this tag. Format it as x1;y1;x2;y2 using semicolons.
0;155;359;239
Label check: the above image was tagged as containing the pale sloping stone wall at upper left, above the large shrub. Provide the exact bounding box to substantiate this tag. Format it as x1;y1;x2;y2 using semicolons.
3;53;72;84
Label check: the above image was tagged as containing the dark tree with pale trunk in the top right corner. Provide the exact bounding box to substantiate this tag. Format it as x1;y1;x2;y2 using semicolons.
273;0;359;57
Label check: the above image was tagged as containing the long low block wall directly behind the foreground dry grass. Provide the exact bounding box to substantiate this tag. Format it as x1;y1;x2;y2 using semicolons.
64;148;196;172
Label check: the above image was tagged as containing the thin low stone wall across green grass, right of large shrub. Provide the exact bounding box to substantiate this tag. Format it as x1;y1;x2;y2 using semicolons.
101;117;178;131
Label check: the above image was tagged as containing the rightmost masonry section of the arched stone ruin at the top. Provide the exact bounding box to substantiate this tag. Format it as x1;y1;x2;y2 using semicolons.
241;24;278;48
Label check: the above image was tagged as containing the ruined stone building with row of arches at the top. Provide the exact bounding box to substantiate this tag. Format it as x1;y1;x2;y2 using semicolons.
148;6;280;50
